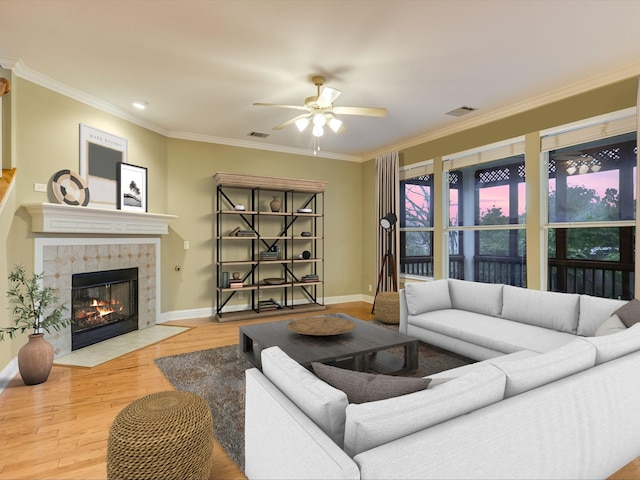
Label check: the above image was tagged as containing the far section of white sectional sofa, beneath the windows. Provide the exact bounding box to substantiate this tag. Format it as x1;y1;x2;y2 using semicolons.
400;279;627;360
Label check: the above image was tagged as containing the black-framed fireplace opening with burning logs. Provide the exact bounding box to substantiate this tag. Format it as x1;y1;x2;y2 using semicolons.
71;268;138;350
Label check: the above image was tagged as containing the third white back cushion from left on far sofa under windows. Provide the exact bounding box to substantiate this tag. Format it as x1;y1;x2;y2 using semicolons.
502;285;580;334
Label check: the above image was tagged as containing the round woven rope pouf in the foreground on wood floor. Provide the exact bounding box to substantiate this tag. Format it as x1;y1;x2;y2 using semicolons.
107;391;213;480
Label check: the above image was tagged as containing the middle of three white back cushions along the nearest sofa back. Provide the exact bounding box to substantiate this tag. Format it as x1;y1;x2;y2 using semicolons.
489;339;596;398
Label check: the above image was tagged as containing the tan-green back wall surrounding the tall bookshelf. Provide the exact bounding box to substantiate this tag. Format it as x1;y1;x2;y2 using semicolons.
162;139;363;311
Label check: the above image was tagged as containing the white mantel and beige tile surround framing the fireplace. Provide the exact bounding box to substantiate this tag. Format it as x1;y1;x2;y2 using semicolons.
25;204;175;358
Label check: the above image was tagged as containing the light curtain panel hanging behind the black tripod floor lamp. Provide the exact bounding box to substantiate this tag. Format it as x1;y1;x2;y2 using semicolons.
376;151;400;293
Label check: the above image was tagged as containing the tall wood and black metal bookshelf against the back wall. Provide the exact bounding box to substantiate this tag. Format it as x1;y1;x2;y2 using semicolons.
214;172;326;321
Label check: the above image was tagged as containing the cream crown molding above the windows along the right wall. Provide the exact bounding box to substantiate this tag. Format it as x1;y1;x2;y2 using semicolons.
364;63;640;159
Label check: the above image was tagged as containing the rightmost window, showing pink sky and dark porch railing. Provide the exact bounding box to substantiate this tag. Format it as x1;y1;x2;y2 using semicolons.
547;128;637;299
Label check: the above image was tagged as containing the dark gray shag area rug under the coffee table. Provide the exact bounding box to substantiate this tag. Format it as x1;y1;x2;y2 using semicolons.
155;321;472;470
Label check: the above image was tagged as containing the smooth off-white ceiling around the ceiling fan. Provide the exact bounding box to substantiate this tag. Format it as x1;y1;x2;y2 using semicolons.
0;0;640;159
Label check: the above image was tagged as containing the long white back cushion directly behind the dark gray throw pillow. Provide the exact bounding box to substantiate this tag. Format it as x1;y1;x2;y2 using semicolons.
344;364;505;456
